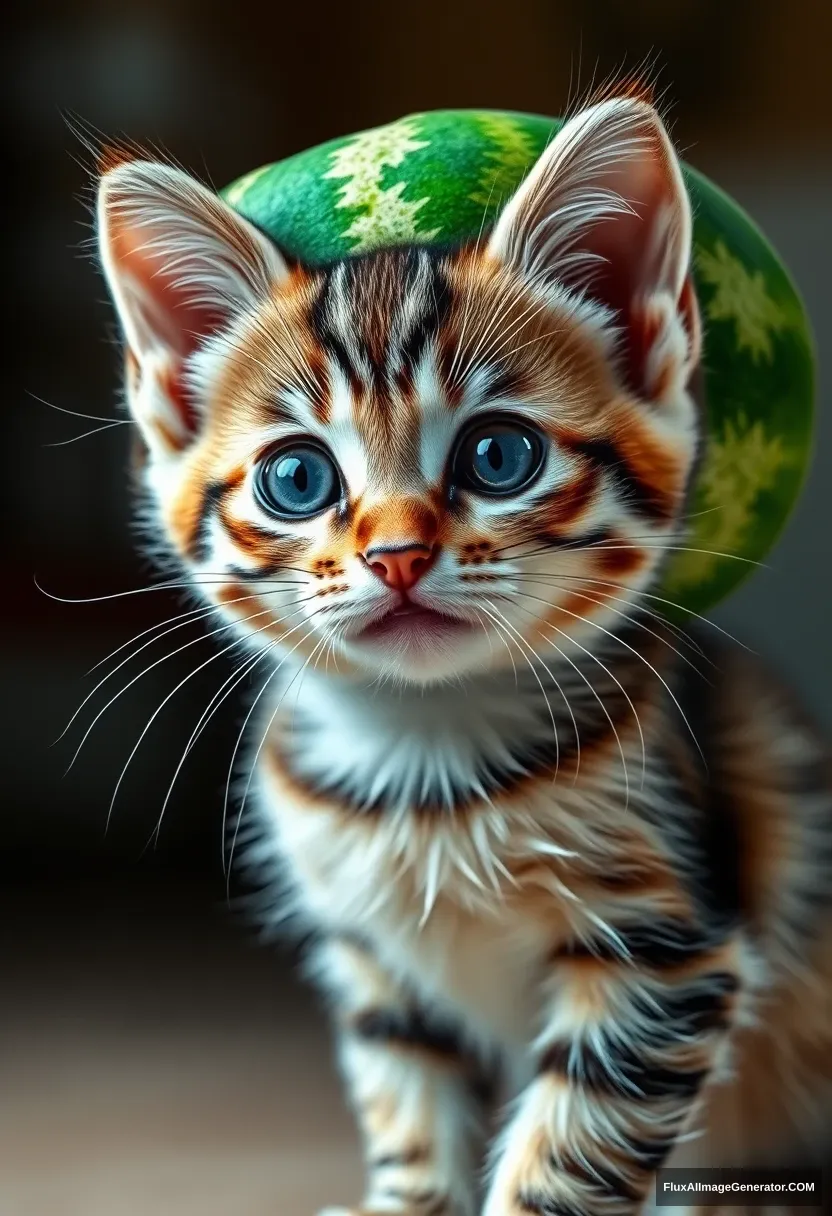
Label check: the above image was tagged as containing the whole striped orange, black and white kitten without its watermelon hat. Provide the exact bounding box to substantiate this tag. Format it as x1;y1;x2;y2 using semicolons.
99;97;832;1216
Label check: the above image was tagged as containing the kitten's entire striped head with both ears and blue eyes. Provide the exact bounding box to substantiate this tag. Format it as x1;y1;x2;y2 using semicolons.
99;98;699;682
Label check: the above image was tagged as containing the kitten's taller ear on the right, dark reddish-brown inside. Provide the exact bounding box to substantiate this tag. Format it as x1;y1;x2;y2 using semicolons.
489;97;701;402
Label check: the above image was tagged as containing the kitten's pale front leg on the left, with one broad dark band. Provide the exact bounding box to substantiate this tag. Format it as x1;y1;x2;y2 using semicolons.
317;936;482;1216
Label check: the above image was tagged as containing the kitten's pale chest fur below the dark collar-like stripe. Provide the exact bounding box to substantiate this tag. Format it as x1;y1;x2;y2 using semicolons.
256;749;547;1046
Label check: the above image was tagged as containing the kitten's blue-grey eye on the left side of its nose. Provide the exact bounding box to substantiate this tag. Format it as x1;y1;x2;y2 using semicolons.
254;443;341;519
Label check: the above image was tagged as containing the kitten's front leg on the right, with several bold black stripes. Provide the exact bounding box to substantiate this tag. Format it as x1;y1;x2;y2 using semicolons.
484;919;738;1216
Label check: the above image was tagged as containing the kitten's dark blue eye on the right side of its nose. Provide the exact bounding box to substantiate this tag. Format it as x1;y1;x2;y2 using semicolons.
454;420;544;494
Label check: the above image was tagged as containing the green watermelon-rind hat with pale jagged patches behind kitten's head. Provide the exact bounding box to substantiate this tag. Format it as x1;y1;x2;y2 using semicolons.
223;109;815;612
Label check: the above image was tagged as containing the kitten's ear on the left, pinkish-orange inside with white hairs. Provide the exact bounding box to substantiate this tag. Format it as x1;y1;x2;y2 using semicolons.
97;161;287;457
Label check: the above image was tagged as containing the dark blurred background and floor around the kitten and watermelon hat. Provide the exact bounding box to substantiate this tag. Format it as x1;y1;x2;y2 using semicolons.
0;0;832;1216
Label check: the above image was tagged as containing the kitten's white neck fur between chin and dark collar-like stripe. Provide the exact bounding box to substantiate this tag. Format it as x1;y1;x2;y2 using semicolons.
262;622;670;811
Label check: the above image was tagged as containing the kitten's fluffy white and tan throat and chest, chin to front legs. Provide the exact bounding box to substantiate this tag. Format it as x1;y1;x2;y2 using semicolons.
250;661;666;1046
